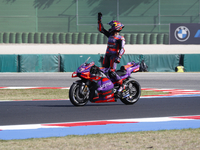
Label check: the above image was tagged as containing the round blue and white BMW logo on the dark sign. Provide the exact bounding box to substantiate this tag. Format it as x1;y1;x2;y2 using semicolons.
174;26;190;42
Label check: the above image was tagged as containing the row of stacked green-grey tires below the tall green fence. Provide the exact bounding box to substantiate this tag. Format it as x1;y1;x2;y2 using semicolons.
0;32;169;44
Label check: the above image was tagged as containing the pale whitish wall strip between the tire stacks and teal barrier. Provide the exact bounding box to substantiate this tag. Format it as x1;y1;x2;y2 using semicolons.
0;44;200;54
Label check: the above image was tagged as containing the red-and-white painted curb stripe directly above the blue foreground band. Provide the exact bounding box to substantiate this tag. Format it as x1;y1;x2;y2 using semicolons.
0;115;200;131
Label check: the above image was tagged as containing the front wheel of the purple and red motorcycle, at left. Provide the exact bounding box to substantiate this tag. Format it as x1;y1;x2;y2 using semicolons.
69;83;89;106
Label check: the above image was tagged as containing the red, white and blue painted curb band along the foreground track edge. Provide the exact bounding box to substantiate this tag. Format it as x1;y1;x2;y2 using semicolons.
0;115;200;140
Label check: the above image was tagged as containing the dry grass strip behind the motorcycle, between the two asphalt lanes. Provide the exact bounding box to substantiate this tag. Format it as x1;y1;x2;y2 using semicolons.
0;89;166;100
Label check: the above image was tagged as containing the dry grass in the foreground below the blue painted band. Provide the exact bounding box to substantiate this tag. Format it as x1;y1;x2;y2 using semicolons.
0;128;200;150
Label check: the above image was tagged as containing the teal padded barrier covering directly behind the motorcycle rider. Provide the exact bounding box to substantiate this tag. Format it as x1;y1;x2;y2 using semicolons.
0;54;200;72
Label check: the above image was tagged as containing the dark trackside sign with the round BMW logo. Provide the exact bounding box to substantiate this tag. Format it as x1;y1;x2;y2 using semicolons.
169;23;200;44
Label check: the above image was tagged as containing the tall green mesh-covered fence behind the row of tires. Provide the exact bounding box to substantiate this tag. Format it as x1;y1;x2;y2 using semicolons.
0;0;200;33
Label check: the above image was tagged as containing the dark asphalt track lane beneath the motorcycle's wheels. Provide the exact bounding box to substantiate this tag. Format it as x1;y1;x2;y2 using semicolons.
0;97;200;125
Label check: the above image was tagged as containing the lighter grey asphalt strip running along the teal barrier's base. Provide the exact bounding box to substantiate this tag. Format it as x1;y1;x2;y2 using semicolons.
0;72;200;90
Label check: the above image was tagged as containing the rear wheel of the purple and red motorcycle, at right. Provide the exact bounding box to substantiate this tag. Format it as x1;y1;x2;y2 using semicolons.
120;80;141;105
